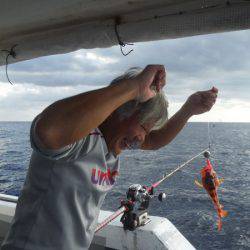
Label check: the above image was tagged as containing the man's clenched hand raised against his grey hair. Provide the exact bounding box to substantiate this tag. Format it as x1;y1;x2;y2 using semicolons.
132;65;166;102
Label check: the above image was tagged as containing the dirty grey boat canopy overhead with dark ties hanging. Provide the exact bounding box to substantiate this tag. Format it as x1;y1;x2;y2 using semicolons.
0;0;250;65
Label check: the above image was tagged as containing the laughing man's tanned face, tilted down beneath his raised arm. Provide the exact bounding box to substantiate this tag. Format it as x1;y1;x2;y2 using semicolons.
110;115;154;155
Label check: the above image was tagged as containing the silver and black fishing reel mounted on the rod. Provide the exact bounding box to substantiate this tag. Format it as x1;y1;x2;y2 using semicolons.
121;184;166;231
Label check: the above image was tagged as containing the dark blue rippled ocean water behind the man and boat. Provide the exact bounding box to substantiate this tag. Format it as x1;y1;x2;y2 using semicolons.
0;122;250;250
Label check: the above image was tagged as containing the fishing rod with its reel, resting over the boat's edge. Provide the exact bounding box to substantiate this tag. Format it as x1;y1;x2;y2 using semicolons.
95;147;210;233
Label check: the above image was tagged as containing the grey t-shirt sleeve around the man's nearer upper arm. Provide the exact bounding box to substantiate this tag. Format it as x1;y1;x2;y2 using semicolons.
30;115;86;160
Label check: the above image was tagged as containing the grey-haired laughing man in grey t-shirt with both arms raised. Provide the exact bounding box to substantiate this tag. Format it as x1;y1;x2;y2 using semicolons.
2;65;218;250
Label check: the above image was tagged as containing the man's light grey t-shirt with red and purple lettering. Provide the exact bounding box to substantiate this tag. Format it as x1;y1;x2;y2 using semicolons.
1;117;119;250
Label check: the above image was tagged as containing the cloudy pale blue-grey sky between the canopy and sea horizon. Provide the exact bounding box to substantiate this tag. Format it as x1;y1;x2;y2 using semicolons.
0;30;250;122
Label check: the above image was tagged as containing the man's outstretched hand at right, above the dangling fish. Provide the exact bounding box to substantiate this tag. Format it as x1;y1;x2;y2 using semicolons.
182;87;218;116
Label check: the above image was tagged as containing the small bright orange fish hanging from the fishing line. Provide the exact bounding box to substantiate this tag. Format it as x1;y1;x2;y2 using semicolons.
195;159;228;231
